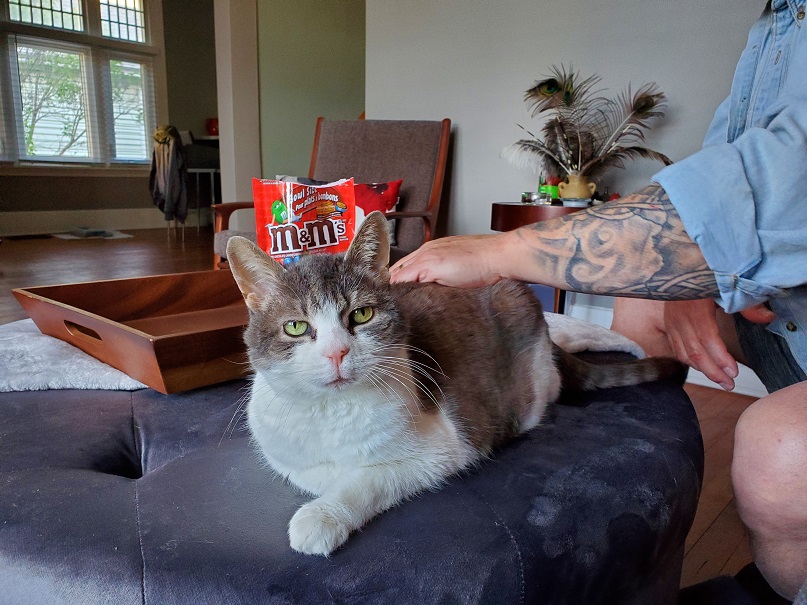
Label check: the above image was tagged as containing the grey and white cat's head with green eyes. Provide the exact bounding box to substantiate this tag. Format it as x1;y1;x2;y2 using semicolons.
227;212;405;393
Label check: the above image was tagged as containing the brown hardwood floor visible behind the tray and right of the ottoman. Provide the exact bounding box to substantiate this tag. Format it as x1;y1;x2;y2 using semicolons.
0;228;754;586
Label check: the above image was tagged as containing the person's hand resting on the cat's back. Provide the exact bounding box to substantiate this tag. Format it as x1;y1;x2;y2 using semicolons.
390;234;509;288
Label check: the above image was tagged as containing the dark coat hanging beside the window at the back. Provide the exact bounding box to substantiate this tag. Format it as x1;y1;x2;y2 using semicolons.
149;126;188;224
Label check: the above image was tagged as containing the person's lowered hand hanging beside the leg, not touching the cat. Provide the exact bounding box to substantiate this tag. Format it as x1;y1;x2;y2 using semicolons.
664;299;739;391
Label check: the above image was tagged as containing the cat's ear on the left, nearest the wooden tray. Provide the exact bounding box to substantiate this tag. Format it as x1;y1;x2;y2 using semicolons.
227;235;286;311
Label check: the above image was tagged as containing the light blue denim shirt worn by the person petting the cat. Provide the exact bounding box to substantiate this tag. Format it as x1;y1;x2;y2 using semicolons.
653;0;807;372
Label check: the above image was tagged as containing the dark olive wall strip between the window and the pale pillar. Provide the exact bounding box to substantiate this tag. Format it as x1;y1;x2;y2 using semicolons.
163;0;218;135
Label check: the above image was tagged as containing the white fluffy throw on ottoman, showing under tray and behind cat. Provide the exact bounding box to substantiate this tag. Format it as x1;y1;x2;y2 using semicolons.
0;313;644;392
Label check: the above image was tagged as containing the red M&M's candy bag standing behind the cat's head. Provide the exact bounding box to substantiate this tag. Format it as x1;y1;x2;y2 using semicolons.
252;179;356;265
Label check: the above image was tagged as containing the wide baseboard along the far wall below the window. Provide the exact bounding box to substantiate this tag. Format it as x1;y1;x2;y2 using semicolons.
0;208;211;236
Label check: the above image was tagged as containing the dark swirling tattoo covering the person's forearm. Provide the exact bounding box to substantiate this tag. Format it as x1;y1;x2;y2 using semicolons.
520;185;718;300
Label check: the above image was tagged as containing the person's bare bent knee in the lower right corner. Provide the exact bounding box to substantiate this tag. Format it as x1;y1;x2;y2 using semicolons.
732;382;807;600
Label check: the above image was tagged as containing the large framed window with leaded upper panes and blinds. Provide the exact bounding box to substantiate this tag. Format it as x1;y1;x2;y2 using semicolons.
0;0;159;165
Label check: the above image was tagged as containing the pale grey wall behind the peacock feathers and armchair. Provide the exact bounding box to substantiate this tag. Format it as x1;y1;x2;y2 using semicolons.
366;0;765;233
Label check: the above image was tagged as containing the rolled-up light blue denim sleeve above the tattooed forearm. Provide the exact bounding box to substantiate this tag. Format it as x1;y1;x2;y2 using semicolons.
653;97;807;313
